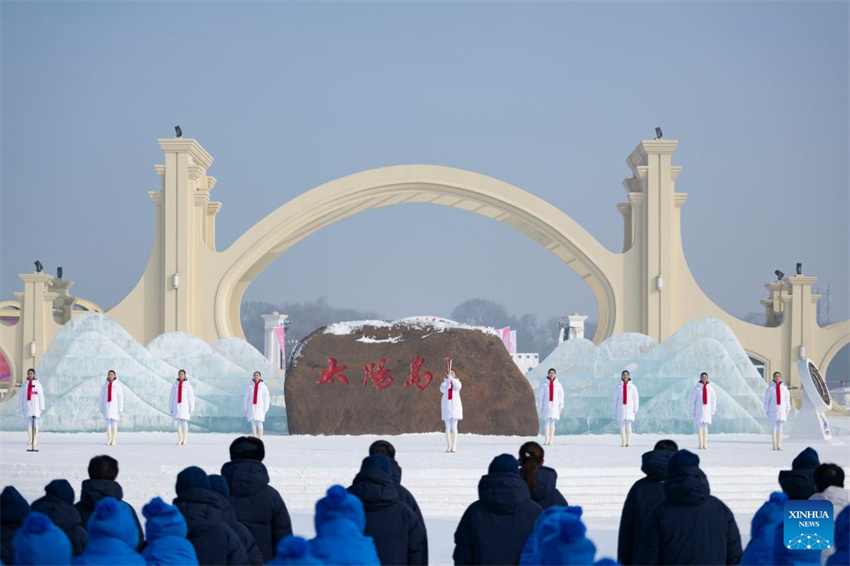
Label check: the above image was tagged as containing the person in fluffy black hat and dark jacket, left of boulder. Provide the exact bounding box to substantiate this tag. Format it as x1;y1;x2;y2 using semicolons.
221;436;292;562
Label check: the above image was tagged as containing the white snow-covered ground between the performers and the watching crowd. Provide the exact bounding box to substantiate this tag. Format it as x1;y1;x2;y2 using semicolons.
0;432;850;564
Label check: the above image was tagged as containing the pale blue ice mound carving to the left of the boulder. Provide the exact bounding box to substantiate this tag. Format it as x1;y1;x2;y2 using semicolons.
0;313;286;433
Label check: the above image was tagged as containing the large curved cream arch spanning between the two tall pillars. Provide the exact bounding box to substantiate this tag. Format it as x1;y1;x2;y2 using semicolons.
214;165;624;342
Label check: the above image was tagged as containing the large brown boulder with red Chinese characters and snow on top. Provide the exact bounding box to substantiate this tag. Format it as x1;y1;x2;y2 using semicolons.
284;319;539;436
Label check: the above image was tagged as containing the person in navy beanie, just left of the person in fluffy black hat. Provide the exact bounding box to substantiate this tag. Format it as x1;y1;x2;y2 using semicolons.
174;466;248;566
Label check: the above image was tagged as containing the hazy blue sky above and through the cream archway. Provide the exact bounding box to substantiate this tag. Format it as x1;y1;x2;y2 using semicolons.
0;1;850;332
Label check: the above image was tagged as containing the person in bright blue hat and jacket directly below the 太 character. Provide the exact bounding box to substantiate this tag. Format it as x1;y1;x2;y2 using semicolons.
310;485;381;566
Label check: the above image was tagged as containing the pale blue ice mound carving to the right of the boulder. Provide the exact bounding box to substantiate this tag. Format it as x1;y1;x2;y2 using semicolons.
527;318;766;434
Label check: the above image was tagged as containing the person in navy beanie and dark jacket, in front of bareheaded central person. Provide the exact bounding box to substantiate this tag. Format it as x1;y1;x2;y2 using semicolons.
348;455;428;565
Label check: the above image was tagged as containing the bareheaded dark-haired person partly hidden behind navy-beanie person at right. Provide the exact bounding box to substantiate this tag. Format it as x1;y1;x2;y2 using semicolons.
617;440;679;566
